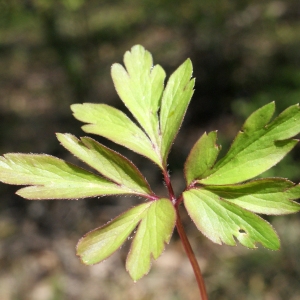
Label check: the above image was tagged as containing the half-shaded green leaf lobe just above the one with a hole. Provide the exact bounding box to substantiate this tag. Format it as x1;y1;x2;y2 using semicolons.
204;178;300;215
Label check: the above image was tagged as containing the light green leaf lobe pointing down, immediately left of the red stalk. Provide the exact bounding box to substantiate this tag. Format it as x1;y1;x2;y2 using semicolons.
126;198;176;281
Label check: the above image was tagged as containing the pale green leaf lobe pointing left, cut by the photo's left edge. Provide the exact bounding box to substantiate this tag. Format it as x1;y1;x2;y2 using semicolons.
0;153;127;200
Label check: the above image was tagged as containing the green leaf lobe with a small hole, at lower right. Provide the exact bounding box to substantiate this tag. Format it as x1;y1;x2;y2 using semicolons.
183;189;280;250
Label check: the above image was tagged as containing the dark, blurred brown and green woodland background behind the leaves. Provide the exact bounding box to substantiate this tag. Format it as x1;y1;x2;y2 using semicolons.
0;0;300;300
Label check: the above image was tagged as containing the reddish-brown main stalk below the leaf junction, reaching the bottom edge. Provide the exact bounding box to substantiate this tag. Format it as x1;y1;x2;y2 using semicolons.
175;206;208;300
